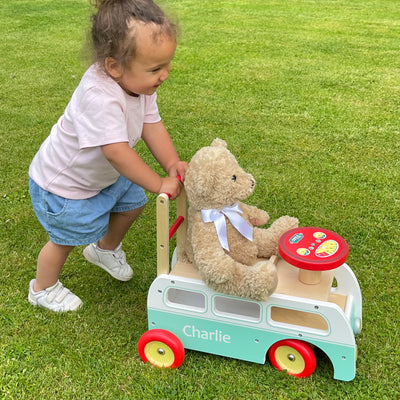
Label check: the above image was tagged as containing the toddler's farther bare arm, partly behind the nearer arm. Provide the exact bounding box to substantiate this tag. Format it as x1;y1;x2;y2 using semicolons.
142;121;188;181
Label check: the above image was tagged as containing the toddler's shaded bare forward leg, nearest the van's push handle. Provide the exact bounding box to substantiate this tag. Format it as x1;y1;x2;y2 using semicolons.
98;206;145;250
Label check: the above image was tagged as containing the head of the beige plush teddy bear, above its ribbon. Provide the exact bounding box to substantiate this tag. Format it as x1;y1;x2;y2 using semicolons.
185;138;255;210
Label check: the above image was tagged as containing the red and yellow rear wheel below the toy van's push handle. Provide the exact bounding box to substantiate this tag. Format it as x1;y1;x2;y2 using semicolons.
138;329;185;368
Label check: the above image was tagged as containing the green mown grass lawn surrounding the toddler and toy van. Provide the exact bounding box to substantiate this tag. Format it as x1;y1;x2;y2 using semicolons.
0;0;400;400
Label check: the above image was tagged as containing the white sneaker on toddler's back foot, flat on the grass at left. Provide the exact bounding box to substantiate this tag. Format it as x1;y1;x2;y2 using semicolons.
28;279;82;312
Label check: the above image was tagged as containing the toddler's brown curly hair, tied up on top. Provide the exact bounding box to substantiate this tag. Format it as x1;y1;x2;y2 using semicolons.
91;0;178;68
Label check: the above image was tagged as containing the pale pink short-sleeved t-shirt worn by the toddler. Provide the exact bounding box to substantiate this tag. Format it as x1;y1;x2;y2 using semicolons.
29;65;161;199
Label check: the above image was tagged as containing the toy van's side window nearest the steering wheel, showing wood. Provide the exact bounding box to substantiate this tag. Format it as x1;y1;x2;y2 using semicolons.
270;306;329;333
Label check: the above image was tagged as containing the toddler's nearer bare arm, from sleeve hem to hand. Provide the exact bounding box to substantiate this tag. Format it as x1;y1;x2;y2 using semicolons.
101;142;181;199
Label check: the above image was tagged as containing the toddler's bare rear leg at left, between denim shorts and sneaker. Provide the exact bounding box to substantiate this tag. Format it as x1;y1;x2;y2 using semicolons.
33;241;74;292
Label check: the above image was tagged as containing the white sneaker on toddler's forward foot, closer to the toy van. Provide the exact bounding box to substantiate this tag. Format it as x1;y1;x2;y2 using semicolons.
83;243;133;281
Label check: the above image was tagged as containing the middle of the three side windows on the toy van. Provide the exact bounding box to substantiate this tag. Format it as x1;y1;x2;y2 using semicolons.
213;296;261;322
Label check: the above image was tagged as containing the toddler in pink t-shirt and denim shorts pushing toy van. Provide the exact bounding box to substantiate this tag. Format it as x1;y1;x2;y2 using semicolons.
28;0;187;311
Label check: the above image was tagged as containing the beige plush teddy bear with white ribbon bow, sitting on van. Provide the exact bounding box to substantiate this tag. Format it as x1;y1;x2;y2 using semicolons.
178;138;298;300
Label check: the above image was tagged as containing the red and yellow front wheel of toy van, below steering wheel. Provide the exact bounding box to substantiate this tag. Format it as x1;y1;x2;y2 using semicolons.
268;339;317;378
